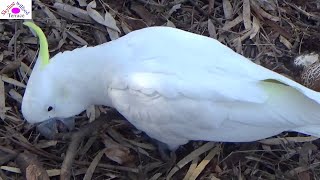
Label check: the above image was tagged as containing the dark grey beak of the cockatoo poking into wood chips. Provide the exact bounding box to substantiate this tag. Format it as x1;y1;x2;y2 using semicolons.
37;117;75;139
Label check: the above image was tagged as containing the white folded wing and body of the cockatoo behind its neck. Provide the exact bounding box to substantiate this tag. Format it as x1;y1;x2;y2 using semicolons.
108;28;320;148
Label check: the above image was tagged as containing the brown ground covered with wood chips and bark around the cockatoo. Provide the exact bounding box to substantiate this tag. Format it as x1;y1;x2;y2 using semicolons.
0;0;320;180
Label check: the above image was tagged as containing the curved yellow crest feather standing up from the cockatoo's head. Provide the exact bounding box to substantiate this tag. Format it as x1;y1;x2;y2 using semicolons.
23;21;49;68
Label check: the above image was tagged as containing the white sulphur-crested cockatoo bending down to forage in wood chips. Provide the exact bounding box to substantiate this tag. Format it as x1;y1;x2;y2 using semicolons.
22;22;320;149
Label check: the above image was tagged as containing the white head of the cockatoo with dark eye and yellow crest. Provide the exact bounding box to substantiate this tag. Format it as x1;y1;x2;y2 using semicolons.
21;22;87;126
